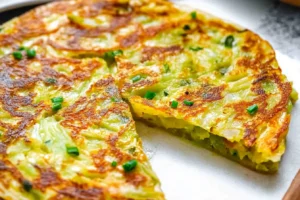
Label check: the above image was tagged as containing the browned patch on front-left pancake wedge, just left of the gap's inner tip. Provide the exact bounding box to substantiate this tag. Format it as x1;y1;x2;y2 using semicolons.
61;76;128;138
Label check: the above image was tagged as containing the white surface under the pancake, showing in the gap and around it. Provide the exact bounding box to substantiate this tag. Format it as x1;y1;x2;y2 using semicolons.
0;0;300;200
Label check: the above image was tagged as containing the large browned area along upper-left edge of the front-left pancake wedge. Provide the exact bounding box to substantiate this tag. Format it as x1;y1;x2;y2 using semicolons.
0;56;102;143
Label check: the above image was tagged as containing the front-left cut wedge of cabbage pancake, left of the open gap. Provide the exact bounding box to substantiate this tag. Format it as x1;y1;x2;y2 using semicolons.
0;54;164;197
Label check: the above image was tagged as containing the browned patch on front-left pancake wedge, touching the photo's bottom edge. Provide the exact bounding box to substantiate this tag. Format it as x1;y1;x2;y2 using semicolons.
52;184;105;200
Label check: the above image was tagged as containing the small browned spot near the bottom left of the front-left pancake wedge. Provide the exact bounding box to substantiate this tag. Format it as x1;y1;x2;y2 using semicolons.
33;166;63;191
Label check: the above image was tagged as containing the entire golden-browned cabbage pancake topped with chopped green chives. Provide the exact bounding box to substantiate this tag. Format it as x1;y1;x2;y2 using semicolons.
0;0;297;199
